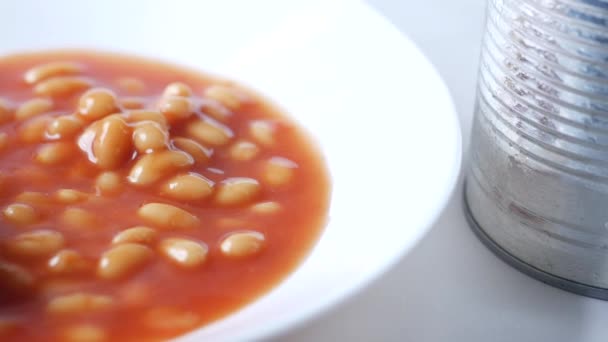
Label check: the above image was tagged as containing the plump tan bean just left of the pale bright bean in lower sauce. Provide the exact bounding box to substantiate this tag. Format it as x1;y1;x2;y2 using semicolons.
97;243;152;279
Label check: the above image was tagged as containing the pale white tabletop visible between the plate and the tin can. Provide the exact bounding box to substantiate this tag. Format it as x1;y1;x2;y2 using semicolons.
277;0;608;342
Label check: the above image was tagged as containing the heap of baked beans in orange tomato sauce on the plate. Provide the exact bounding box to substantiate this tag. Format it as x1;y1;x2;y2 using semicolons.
0;51;327;341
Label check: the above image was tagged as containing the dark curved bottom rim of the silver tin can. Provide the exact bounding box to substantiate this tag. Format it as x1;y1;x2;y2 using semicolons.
462;180;608;301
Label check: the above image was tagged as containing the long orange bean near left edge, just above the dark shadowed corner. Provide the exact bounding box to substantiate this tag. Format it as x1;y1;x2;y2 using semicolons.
4;230;64;258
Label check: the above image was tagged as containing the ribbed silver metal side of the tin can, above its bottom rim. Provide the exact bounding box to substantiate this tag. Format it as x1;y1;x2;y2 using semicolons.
465;0;608;297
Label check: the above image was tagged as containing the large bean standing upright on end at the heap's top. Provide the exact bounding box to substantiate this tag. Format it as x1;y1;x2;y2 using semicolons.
93;116;132;170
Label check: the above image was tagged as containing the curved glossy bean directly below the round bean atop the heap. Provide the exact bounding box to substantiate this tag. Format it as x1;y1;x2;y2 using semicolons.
127;151;194;186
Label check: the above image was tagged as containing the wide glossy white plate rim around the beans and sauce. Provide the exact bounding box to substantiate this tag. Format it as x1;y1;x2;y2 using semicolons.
0;0;461;341
